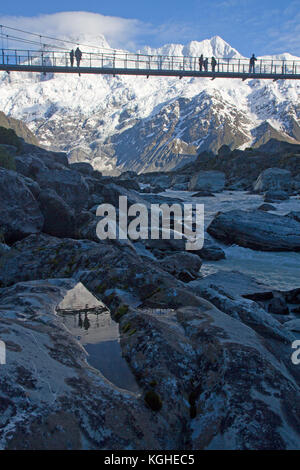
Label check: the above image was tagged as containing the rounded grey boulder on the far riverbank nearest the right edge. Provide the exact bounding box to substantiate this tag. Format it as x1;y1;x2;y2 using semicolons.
253;168;292;193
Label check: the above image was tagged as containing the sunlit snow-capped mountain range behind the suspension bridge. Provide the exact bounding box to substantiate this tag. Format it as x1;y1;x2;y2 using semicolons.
0;36;300;172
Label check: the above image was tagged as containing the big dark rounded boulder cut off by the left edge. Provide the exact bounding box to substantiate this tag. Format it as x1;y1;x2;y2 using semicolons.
0;168;44;243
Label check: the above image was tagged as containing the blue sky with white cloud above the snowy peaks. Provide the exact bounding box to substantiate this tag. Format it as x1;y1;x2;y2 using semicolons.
0;0;300;56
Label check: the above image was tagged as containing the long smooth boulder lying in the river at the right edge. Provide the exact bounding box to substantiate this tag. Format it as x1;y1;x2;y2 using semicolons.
207;210;300;251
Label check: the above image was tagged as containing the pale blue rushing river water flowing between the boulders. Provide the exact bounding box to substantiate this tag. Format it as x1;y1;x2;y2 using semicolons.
161;191;300;290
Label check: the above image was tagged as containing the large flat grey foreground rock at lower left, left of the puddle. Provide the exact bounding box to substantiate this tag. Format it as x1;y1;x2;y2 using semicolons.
0;279;169;450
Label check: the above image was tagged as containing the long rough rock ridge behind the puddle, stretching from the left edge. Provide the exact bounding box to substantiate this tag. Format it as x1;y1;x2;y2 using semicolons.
0;233;181;306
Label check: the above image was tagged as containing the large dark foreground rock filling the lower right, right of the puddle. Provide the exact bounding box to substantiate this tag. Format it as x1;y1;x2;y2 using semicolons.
121;300;299;449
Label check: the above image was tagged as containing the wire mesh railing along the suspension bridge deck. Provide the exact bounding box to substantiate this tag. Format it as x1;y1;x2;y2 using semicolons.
0;49;300;75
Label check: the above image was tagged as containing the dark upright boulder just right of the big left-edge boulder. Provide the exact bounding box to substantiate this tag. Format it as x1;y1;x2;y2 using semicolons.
38;189;76;238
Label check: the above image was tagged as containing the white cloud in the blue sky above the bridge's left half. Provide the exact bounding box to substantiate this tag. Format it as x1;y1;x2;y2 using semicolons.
0;11;151;49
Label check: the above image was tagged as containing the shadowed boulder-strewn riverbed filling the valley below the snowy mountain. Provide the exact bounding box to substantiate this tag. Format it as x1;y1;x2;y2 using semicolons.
0;127;300;449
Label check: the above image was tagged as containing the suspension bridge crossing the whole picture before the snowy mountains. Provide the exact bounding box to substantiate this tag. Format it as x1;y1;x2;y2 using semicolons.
0;48;300;81
